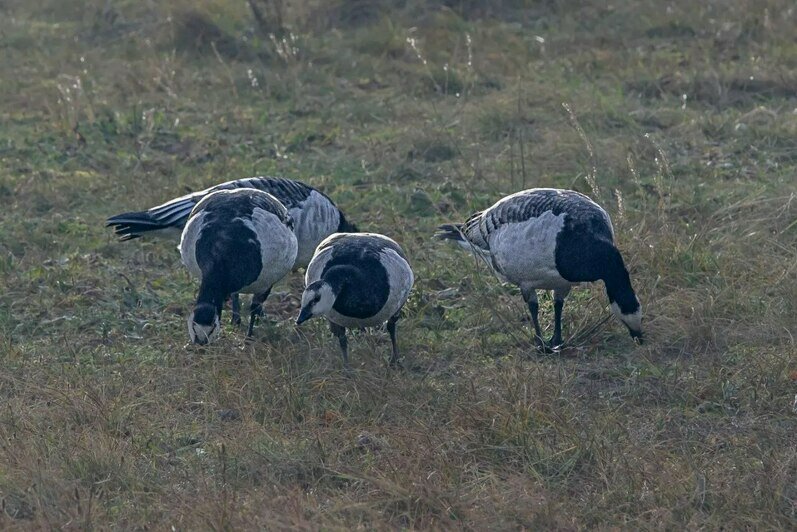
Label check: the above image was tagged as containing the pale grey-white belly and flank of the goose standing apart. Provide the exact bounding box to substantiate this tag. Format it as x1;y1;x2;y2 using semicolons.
488;211;573;289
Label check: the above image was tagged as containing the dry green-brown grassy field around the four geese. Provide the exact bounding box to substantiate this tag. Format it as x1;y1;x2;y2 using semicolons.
0;0;797;530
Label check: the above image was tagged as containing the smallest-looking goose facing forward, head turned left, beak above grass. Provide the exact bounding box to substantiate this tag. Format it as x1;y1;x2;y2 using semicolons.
296;233;414;368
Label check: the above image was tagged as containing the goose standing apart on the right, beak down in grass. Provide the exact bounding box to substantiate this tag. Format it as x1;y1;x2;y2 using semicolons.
435;188;642;350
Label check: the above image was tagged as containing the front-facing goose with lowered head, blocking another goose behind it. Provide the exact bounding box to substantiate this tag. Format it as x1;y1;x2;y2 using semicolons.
179;188;298;344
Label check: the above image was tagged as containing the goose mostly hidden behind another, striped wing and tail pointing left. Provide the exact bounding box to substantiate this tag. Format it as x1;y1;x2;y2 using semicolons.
106;177;357;323
